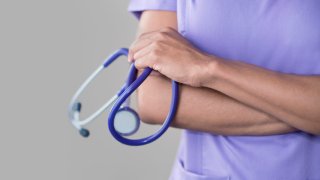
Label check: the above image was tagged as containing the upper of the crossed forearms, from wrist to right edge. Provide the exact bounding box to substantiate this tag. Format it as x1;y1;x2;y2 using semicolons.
204;60;320;134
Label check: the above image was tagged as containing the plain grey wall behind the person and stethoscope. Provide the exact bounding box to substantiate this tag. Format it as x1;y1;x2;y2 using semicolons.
0;0;180;180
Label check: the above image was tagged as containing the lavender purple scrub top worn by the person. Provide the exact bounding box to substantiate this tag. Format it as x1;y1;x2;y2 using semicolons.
129;0;320;180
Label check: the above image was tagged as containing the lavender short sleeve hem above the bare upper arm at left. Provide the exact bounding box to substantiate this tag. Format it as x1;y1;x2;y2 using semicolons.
128;0;177;18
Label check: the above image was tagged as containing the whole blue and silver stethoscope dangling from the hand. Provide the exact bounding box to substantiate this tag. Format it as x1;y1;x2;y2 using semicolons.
68;48;179;146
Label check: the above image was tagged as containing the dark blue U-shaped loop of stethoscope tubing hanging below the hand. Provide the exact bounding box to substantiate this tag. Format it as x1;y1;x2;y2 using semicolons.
108;68;179;146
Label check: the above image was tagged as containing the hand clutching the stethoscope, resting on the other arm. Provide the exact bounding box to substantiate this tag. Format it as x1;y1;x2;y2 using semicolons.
128;28;214;87
